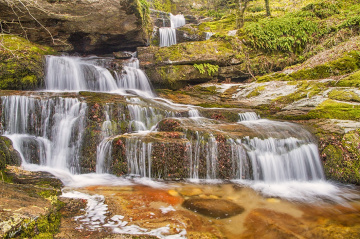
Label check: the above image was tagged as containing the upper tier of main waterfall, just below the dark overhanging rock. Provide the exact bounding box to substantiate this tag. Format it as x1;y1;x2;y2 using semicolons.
45;56;155;97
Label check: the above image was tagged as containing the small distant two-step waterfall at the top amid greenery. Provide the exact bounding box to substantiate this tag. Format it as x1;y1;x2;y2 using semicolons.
159;13;185;47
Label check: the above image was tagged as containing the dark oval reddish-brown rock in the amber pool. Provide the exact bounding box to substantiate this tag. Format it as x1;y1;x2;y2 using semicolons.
182;199;244;218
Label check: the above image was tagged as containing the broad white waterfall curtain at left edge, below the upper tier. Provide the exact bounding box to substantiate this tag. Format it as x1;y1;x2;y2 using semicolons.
1;96;87;173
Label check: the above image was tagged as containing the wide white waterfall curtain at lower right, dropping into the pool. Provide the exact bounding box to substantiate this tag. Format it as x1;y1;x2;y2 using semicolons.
244;137;325;182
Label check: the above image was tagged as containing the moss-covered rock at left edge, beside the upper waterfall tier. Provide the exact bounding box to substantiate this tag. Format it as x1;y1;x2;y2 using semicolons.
0;34;56;90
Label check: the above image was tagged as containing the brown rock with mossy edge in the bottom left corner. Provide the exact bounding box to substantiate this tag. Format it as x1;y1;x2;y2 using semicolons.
0;167;62;238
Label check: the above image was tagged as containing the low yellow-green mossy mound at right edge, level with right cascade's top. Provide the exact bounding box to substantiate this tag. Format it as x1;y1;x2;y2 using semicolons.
307;100;360;120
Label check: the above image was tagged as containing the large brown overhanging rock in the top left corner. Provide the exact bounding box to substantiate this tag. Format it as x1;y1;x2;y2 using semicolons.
0;0;146;54
